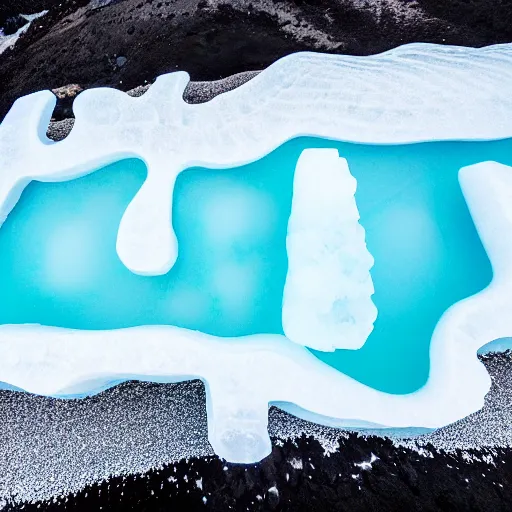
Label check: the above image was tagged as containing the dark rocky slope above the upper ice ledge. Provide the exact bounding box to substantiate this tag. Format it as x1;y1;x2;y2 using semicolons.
0;0;512;119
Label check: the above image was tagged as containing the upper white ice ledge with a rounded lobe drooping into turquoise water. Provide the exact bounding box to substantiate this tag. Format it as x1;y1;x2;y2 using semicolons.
0;44;512;275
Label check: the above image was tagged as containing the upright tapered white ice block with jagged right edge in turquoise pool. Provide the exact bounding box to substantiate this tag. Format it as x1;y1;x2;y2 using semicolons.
283;149;377;351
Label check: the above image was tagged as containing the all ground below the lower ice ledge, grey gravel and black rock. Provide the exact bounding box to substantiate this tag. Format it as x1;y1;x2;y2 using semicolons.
0;352;512;511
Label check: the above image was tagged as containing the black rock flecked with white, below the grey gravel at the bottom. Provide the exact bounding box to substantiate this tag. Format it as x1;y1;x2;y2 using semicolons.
4;434;512;512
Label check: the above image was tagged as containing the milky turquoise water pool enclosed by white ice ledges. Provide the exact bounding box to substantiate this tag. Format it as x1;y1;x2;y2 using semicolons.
0;138;512;393
